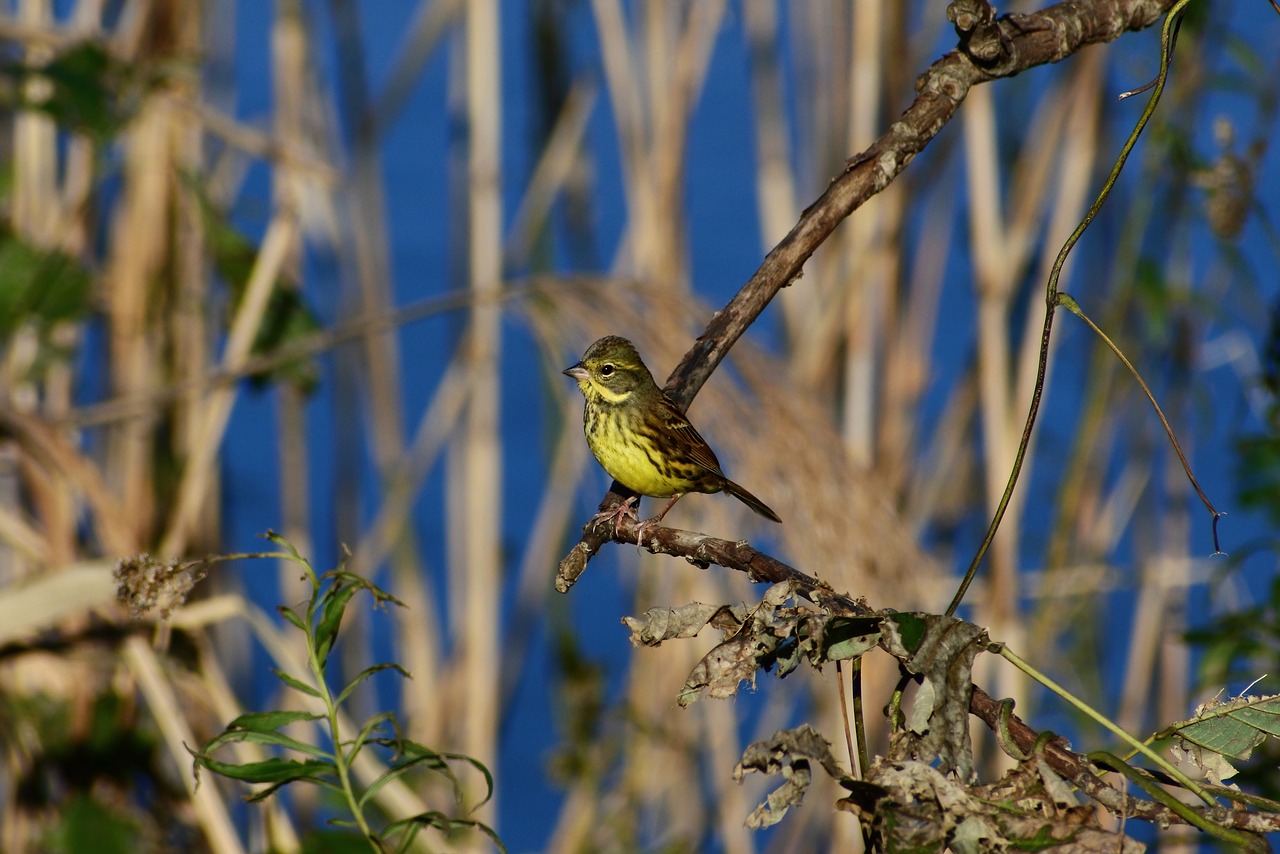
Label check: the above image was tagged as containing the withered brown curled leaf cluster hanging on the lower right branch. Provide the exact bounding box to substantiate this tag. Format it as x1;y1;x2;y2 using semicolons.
634;573;1280;851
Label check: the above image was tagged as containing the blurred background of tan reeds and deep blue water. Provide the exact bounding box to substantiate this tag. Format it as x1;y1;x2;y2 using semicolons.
0;0;1280;851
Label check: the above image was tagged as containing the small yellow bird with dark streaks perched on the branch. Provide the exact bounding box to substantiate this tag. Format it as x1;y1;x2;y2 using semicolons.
563;335;782;525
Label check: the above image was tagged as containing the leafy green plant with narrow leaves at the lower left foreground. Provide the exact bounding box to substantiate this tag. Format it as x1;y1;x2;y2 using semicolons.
195;533;506;851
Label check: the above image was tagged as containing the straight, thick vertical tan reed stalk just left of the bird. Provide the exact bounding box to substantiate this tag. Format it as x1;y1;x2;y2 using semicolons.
451;0;504;817
